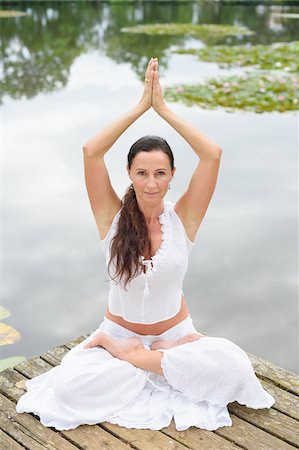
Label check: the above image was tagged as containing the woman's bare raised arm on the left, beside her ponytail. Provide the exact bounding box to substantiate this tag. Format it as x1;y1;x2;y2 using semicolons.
83;59;154;239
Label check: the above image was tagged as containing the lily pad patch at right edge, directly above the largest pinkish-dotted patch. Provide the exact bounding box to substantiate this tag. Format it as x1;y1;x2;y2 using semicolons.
175;41;299;72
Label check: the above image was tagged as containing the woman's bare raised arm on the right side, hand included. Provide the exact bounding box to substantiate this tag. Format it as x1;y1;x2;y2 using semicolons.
152;62;222;241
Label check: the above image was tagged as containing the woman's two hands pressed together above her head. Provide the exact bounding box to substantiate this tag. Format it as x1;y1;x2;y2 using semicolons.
139;58;166;112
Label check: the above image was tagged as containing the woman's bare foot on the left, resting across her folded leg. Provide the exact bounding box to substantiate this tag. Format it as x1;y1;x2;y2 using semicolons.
84;332;144;359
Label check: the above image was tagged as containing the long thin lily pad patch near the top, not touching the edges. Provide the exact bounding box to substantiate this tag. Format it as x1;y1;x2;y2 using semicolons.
121;23;255;42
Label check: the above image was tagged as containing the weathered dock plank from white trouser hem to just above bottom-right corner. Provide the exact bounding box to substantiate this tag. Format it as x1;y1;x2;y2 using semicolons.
228;402;299;447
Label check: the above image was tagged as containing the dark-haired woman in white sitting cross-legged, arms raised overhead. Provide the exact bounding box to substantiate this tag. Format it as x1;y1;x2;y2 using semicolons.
17;58;275;430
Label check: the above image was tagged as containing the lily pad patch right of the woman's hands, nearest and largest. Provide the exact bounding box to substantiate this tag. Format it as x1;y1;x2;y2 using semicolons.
164;71;299;113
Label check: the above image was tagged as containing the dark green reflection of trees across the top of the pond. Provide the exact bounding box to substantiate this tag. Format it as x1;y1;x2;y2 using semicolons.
0;2;299;103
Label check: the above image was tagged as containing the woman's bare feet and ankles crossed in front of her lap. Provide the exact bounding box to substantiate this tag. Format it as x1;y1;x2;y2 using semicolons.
84;332;202;375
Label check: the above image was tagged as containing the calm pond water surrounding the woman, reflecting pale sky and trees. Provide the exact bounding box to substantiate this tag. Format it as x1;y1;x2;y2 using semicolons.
0;2;299;372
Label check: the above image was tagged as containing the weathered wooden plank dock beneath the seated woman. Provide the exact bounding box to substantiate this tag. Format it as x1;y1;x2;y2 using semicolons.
0;336;299;450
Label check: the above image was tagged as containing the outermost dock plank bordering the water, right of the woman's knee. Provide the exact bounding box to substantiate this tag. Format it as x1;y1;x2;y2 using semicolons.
246;352;299;395
